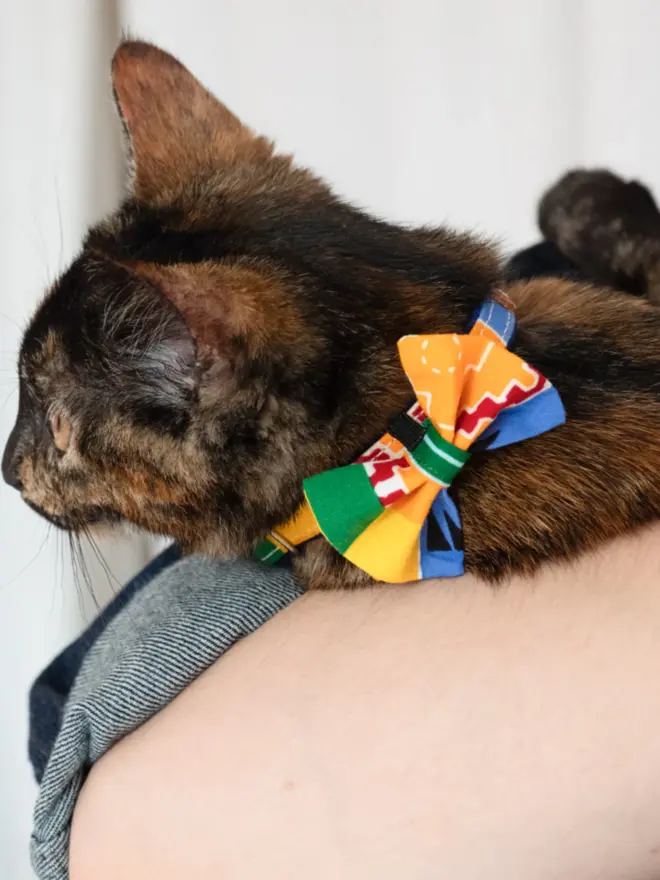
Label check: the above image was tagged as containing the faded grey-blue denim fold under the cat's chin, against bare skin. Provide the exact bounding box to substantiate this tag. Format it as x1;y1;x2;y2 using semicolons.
31;557;302;880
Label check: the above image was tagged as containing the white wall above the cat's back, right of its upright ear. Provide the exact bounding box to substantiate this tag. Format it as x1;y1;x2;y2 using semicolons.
124;0;660;243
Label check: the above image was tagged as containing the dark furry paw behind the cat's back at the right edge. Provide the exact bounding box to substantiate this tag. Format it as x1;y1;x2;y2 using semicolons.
539;170;660;293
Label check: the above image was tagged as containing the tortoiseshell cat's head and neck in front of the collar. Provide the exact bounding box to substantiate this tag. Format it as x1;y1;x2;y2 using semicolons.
3;42;495;552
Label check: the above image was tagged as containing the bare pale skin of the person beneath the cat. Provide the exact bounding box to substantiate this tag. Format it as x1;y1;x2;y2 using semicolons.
70;525;660;880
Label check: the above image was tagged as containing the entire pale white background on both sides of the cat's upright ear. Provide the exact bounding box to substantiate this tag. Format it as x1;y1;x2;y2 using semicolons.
0;0;660;880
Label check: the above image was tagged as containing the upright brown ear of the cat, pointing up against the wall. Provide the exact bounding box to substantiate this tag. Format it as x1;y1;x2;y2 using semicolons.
112;40;271;203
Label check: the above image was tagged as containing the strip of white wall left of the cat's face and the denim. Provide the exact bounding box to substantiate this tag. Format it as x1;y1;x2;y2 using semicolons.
0;0;151;880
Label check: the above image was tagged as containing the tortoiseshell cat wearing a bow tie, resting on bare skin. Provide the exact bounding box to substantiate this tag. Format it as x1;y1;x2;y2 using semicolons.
3;42;660;587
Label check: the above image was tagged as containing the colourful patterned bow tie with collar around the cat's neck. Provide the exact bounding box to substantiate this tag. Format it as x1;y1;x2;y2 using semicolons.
255;299;566;583
